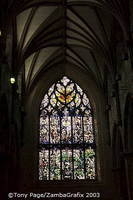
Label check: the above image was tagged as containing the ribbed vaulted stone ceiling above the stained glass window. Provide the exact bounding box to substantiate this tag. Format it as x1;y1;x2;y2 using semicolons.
0;0;128;92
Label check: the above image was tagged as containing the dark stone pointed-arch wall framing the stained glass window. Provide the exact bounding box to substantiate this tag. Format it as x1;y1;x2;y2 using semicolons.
21;64;111;194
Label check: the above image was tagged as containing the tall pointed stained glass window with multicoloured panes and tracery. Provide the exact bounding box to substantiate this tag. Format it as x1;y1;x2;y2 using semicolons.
39;76;96;180
